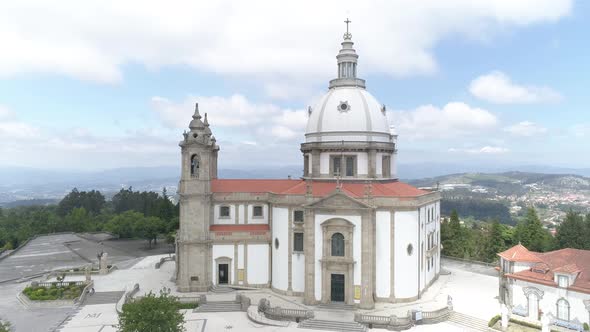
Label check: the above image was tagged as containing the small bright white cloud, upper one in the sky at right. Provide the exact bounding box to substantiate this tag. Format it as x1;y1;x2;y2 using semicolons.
469;71;562;104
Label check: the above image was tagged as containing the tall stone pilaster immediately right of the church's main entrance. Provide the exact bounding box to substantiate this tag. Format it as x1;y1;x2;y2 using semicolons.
360;209;375;309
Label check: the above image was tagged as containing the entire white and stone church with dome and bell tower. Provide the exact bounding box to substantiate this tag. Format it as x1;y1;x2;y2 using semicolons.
176;25;440;309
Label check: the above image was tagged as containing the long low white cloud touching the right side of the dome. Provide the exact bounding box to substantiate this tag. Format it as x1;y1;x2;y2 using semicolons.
389;102;498;139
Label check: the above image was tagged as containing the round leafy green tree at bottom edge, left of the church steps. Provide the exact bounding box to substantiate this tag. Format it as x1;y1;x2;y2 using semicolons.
119;291;185;332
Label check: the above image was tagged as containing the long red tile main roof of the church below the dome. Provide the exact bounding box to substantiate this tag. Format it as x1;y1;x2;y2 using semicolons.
211;179;429;198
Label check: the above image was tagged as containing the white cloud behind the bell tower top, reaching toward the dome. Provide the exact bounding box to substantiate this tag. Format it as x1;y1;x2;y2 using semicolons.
152;94;307;141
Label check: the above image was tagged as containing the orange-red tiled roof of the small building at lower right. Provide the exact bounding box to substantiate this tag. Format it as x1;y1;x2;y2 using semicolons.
498;244;590;294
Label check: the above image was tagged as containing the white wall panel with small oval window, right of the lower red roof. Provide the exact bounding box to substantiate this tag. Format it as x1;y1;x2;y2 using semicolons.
274;207;290;291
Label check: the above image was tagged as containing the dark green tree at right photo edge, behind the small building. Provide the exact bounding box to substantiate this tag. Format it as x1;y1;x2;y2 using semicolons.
555;210;590;249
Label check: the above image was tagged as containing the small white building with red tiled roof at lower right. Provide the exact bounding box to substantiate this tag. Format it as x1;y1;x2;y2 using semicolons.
498;243;590;330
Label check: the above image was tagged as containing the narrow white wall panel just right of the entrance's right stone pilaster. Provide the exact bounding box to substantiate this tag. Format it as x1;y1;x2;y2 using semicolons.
375;211;391;297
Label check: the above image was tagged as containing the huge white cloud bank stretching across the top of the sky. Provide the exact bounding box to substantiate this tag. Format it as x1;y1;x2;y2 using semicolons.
0;0;572;94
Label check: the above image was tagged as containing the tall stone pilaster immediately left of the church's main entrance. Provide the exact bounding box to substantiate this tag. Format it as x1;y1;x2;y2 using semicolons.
303;209;317;305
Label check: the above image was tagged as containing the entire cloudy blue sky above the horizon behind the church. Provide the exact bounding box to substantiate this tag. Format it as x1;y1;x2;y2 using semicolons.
0;0;590;176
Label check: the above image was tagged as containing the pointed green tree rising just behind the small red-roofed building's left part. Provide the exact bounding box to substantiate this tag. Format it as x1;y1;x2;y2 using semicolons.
514;207;554;252
